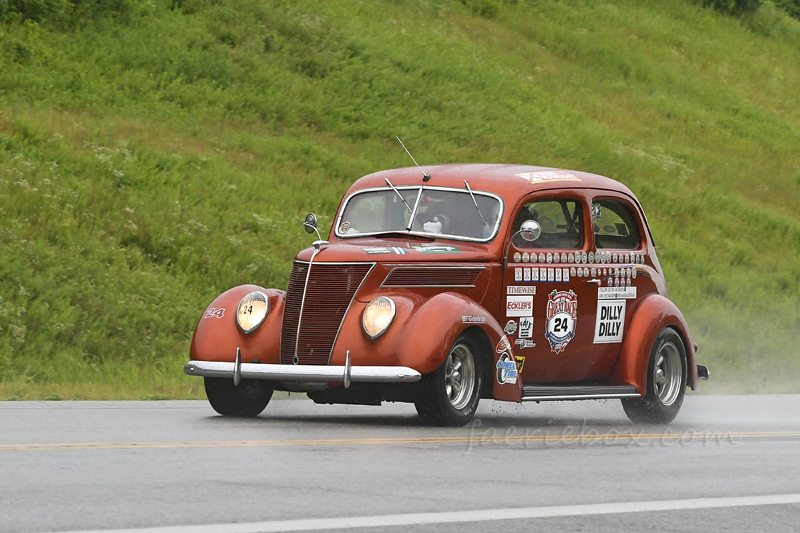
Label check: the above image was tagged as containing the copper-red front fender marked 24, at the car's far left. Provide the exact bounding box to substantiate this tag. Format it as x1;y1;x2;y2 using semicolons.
189;285;286;364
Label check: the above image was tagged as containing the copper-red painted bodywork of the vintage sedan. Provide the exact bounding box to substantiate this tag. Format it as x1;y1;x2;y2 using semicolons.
191;165;697;401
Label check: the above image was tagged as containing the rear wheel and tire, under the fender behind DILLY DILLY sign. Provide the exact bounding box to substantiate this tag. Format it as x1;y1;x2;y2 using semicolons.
622;328;687;424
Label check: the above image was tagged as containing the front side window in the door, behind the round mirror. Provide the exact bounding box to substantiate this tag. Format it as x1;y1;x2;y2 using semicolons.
513;199;584;250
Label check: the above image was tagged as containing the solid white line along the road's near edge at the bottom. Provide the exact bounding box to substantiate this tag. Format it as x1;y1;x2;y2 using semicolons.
53;494;800;533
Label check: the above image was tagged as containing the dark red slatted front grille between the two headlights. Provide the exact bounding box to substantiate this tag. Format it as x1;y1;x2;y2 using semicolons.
281;261;374;365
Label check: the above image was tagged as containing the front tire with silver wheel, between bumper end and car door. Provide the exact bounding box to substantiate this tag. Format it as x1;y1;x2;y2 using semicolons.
414;333;483;427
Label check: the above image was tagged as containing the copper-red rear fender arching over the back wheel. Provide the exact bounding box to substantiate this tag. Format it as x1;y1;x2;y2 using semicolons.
612;293;697;396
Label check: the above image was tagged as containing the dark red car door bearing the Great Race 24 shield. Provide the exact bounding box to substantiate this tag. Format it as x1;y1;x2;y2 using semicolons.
502;190;619;383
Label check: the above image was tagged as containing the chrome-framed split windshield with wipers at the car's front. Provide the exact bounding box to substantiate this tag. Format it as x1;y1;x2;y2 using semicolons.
336;187;503;241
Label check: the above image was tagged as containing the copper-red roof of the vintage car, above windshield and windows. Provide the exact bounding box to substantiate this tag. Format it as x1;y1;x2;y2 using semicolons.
347;163;635;203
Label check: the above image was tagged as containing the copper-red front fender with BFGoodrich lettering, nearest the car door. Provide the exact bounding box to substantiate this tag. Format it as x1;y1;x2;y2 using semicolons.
331;292;522;401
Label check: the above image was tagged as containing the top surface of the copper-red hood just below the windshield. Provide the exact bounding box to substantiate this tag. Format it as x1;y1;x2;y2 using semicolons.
295;237;499;263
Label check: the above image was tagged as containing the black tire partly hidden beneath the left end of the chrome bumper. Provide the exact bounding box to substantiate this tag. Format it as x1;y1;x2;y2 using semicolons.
203;377;272;417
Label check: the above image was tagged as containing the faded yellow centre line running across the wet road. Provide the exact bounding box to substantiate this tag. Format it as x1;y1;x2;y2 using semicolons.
0;427;800;452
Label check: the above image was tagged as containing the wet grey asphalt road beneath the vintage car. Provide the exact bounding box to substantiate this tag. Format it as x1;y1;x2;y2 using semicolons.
0;395;800;533
